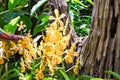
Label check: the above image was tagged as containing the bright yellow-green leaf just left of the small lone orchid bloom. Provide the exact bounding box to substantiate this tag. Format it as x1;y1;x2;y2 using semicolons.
4;16;20;34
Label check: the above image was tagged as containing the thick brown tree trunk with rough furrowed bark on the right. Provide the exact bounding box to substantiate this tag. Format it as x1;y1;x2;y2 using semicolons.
81;0;120;77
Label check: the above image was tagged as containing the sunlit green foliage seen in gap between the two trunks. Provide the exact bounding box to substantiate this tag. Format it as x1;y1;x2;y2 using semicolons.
67;0;93;36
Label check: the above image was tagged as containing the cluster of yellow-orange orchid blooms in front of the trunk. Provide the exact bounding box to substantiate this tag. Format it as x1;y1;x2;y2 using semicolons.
0;9;80;80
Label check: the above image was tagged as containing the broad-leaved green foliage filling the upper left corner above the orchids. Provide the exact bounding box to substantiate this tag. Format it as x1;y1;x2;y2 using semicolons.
0;0;48;35
